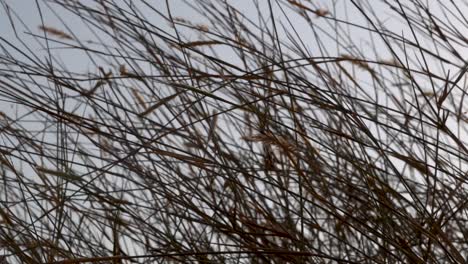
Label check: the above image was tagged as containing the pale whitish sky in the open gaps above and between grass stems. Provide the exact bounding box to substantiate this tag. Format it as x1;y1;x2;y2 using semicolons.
0;0;468;260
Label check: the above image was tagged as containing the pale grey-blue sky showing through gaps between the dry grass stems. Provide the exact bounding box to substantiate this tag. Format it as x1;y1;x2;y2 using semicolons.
4;0;466;260
